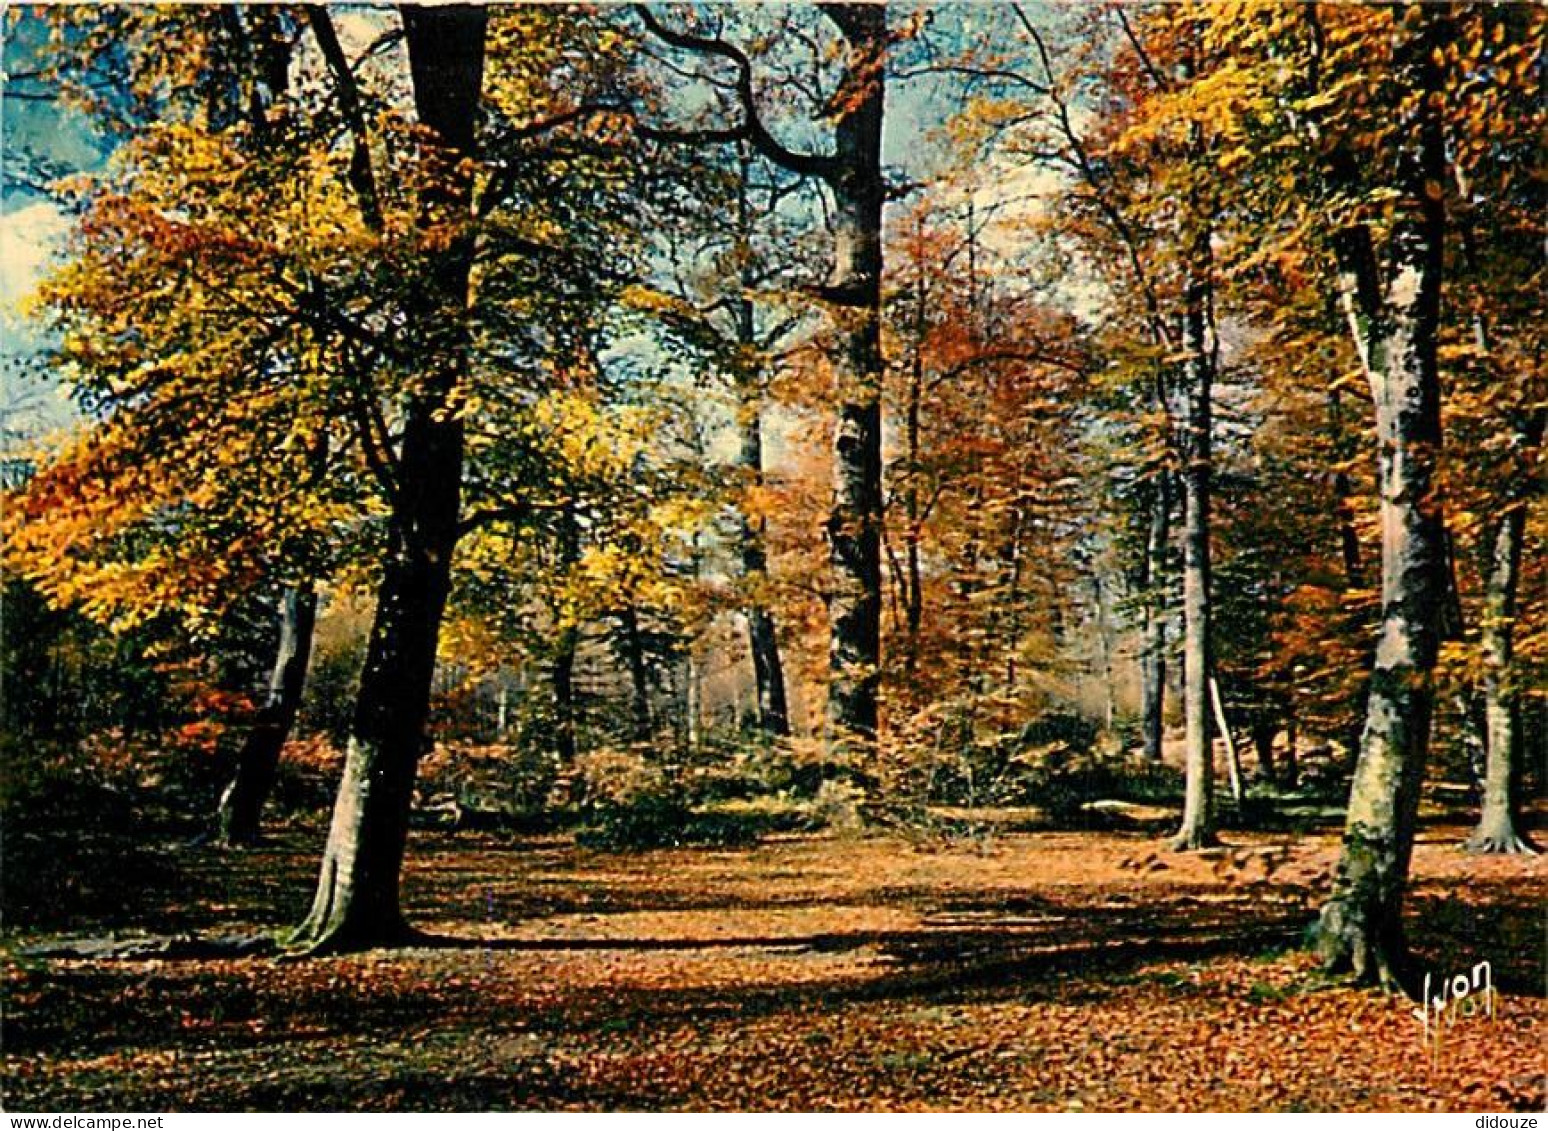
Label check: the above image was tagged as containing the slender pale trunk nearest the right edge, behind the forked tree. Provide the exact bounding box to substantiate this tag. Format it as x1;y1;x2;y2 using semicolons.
1466;492;1540;854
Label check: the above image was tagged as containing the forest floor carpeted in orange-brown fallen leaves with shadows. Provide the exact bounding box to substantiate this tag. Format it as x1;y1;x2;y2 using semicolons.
3;825;1548;1112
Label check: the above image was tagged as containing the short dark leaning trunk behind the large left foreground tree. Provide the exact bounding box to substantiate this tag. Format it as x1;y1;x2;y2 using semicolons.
218;583;317;845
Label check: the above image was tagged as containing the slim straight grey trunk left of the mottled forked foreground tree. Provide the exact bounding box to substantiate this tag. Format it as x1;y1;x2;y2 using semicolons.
1172;236;1215;851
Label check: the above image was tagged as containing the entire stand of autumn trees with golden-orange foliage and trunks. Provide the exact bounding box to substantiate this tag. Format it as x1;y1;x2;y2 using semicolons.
5;3;1548;981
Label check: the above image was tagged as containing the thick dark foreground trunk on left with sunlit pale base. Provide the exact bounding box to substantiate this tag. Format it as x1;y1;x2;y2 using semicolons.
293;6;488;953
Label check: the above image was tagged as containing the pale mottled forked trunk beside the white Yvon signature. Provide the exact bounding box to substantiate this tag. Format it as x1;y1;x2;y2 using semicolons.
1317;14;1446;986
